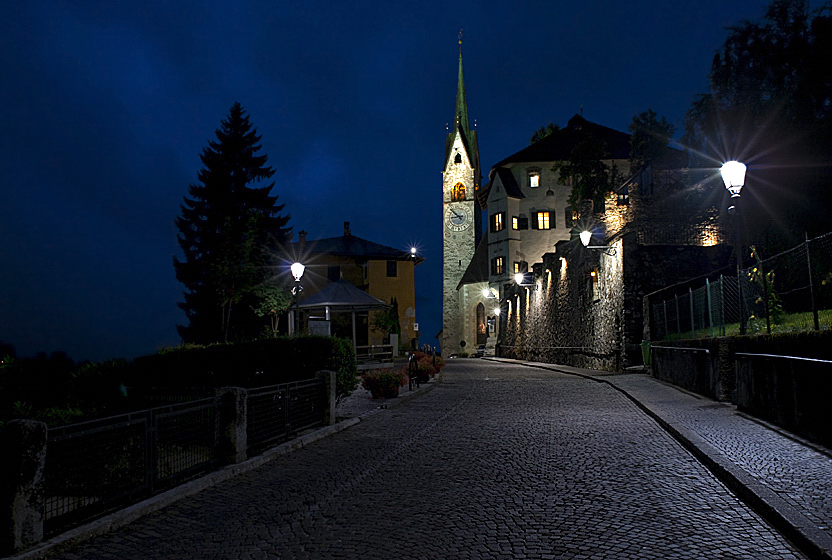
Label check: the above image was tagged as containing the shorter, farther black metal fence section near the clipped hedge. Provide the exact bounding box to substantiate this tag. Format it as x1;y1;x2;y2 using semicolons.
246;380;329;455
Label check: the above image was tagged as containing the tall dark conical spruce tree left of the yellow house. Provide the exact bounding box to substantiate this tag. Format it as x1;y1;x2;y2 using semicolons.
173;103;291;344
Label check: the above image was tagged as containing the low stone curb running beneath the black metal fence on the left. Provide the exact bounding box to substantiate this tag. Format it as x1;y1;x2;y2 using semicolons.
7;418;361;560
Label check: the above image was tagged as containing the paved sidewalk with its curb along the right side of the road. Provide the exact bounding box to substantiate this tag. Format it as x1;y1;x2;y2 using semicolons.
486;358;832;559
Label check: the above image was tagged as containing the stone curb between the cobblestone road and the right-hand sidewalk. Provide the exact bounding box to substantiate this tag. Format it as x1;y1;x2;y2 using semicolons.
493;359;832;560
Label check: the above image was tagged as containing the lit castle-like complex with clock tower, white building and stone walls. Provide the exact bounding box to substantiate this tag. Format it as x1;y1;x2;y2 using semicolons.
441;42;726;369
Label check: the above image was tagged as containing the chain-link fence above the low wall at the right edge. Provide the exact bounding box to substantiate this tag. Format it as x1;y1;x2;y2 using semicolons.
648;233;832;340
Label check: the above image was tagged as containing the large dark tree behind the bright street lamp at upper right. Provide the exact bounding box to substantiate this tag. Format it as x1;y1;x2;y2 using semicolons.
682;0;832;251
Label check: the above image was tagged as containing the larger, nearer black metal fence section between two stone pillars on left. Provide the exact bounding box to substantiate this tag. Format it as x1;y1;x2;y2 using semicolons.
44;398;219;535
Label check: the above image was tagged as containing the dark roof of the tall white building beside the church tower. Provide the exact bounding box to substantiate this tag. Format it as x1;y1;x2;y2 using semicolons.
494;115;630;168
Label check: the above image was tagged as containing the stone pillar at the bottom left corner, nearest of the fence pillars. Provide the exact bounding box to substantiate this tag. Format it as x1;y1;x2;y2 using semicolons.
0;420;46;554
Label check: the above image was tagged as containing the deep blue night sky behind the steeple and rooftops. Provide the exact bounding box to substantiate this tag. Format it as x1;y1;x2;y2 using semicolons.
0;0;768;360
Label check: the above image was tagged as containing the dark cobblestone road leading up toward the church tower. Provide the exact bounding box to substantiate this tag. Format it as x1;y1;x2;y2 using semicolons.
47;360;802;560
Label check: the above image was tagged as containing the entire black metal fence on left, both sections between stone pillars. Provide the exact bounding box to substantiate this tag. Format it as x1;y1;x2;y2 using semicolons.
44;380;329;537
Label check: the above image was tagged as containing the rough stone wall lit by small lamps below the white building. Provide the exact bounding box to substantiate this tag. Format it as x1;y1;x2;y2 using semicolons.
501;232;731;371
